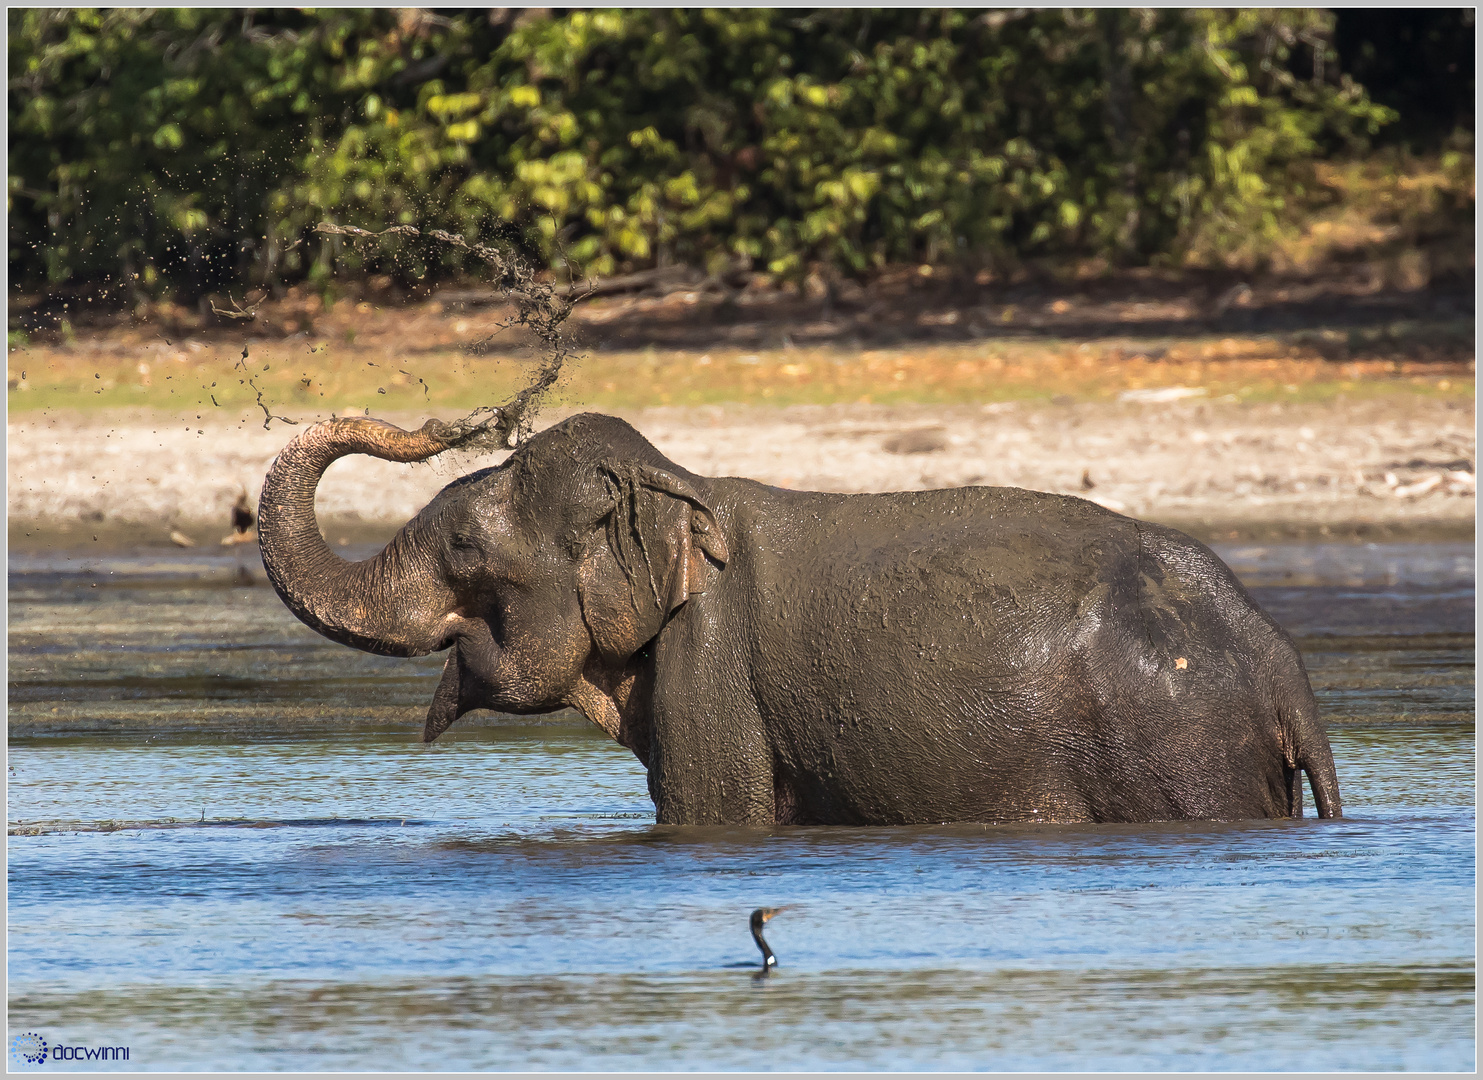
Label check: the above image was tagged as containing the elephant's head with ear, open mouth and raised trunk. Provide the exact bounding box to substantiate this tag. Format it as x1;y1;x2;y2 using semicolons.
258;414;728;750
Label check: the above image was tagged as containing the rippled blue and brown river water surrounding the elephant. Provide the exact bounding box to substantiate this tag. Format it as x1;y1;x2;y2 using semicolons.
7;544;1476;1071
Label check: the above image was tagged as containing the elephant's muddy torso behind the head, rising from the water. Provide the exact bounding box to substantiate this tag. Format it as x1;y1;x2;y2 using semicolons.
634;481;1338;825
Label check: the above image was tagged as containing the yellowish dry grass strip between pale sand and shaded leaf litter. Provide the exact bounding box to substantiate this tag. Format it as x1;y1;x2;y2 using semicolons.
9;329;1474;420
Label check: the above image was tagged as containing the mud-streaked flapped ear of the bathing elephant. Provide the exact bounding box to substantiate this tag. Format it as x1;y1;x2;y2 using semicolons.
578;466;731;659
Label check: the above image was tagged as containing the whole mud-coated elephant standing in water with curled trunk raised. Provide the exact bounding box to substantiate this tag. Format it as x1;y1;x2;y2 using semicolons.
260;414;1341;825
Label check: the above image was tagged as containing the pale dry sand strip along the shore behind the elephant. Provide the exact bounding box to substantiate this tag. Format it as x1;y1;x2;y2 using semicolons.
7;395;1477;547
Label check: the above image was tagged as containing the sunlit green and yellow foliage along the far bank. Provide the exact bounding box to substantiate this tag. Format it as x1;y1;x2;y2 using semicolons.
7;9;1394;292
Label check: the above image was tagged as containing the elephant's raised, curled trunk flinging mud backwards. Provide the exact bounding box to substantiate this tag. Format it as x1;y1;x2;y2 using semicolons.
258;417;458;656
